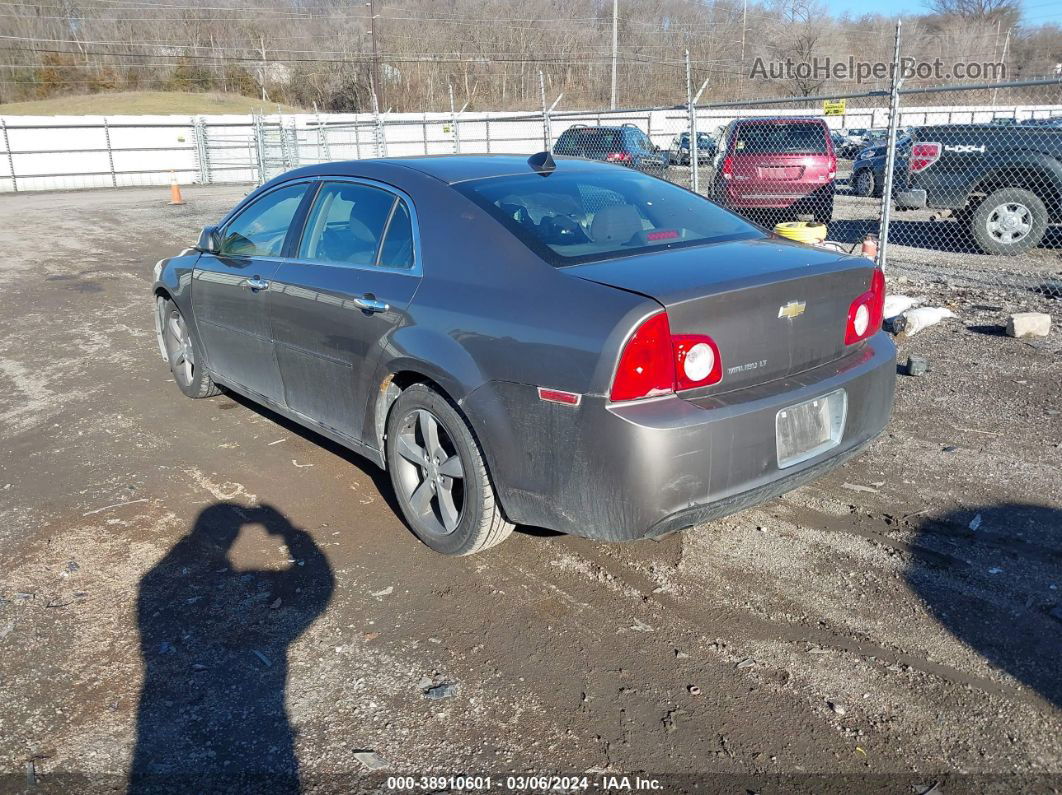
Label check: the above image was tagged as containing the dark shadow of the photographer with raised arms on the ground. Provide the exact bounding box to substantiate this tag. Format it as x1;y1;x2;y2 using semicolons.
129;503;335;793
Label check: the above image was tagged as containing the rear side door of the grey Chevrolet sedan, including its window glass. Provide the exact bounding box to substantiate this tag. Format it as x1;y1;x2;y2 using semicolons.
269;179;421;440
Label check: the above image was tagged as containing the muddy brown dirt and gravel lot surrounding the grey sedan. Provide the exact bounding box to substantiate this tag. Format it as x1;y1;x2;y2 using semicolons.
0;188;1062;793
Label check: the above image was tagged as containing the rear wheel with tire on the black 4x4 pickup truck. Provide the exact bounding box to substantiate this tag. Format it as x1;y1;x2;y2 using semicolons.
970;188;1048;257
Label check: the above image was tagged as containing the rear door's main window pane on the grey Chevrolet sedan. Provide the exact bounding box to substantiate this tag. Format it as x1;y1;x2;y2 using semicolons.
298;183;396;266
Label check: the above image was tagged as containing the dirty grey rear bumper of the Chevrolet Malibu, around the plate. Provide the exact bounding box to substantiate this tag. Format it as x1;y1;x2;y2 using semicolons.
466;333;895;541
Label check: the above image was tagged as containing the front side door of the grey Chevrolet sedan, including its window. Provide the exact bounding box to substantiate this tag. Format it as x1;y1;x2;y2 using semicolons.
192;182;309;402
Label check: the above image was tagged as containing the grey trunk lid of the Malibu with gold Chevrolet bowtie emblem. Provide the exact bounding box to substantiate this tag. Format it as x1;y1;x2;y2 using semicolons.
564;238;874;398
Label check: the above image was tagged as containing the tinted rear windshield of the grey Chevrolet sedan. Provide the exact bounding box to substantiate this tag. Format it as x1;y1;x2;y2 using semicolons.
455;166;764;266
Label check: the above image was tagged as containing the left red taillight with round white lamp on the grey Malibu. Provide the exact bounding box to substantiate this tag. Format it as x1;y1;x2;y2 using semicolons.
610;312;723;400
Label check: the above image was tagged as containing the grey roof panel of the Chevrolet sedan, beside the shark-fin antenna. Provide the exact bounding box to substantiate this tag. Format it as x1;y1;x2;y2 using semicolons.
290;155;616;185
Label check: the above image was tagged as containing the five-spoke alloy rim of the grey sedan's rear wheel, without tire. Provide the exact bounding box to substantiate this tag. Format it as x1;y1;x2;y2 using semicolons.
394;409;464;536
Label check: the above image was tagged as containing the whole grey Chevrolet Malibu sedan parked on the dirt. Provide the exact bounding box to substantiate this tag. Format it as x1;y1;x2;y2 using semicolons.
154;153;895;555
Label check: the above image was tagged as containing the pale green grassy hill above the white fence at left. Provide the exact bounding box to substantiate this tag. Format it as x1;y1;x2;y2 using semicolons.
0;91;298;116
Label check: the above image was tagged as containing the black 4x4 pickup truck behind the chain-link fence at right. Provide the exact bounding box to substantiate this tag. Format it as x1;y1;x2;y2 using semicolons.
895;124;1062;256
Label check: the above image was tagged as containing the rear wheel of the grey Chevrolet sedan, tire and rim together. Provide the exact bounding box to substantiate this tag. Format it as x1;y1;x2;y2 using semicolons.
384;384;513;555
